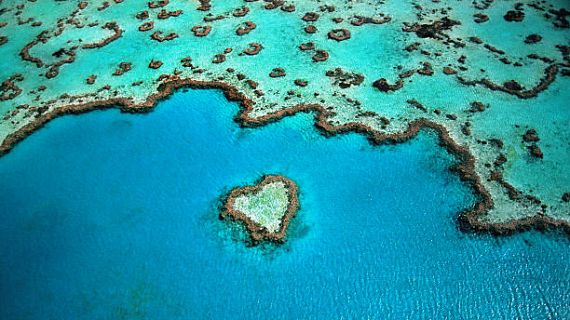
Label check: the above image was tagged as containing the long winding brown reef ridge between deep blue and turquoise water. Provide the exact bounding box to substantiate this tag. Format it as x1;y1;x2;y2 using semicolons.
0;76;570;235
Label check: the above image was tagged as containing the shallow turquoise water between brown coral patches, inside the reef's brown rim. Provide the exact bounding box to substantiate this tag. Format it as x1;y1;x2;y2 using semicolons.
0;0;570;228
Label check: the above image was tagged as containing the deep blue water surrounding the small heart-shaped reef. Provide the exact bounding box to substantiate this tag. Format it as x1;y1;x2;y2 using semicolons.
0;91;570;319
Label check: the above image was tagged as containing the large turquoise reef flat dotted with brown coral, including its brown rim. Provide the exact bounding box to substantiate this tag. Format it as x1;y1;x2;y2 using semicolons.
0;0;570;234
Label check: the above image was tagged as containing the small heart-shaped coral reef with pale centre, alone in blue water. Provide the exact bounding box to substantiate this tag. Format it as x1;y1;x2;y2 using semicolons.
220;175;299;242
